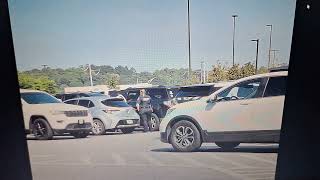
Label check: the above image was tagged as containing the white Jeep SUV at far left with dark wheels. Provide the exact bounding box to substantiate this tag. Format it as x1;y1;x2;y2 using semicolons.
20;89;92;140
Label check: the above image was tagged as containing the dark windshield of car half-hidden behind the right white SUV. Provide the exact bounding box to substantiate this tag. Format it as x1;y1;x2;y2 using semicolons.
176;86;212;97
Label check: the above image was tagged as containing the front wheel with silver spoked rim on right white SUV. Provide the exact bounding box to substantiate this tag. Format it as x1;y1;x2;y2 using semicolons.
170;120;202;152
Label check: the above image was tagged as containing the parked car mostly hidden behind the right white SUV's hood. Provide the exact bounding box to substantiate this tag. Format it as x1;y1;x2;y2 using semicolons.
173;82;230;105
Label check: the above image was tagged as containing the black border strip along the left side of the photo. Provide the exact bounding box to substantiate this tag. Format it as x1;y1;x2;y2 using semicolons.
0;0;32;180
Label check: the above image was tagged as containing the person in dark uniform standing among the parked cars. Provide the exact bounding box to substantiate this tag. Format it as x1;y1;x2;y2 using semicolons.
136;89;152;132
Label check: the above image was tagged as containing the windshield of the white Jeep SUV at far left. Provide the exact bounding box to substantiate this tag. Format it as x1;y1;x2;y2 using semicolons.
21;92;61;104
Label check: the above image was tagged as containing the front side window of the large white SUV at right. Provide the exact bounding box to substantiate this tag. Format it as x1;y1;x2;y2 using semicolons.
217;78;263;101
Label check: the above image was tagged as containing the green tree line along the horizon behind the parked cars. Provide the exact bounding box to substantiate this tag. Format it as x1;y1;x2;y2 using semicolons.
18;63;267;94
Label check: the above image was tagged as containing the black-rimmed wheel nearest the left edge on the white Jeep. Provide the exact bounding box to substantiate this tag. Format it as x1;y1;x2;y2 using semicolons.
32;118;53;140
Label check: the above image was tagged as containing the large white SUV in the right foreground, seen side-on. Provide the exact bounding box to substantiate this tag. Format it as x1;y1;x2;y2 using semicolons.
160;71;287;151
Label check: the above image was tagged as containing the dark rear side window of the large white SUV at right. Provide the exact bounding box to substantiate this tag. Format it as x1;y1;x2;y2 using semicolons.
264;76;287;97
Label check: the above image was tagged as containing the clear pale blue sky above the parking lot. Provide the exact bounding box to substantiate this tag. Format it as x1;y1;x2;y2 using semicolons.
9;0;295;72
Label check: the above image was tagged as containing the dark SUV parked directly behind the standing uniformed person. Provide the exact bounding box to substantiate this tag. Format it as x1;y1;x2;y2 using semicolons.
119;86;178;131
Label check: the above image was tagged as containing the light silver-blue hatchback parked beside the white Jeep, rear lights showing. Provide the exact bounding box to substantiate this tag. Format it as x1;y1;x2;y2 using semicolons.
65;96;140;135
